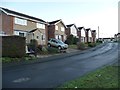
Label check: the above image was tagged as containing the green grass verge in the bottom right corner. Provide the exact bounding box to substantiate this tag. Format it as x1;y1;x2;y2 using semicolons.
59;66;120;88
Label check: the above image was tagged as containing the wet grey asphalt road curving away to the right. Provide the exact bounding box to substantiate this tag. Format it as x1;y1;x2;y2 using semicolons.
2;43;118;88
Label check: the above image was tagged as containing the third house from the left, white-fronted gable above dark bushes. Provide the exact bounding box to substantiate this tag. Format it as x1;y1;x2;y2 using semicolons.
65;24;78;38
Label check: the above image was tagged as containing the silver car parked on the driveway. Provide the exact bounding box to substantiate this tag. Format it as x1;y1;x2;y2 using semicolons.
48;38;68;50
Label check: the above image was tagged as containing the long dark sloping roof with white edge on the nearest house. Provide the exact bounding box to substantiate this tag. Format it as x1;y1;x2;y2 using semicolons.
0;7;46;23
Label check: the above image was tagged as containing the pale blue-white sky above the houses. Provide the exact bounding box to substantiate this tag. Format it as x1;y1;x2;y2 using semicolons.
0;0;119;38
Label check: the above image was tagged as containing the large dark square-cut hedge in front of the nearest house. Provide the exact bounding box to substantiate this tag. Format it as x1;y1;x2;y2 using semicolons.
0;36;26;57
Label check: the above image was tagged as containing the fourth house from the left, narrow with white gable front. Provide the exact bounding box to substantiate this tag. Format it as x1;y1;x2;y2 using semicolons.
77;27;87;43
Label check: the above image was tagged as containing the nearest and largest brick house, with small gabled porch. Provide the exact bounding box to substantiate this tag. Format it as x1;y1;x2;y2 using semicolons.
0;7;48;45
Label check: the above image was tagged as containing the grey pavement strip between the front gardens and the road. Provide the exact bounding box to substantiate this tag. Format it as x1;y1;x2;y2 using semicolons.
2;43;106;68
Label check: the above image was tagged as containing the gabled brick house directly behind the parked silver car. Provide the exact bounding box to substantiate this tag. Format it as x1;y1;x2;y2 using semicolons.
48;19;67;42
